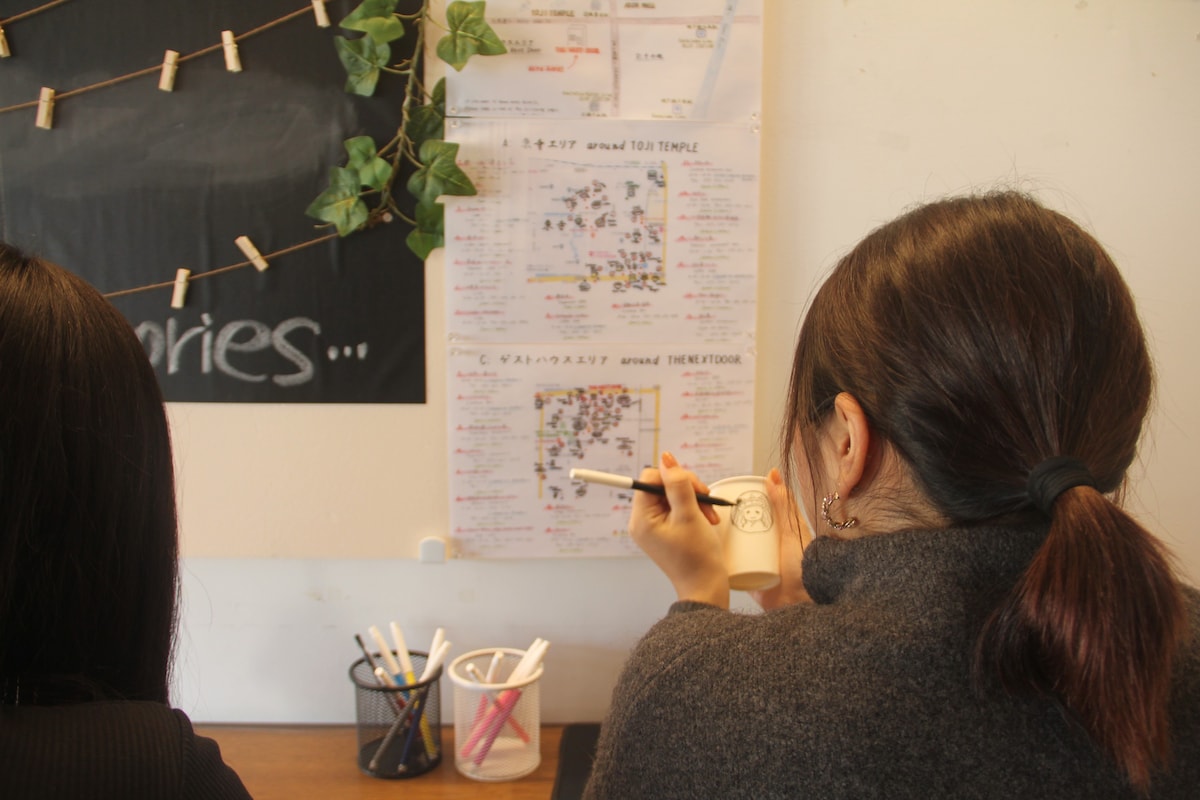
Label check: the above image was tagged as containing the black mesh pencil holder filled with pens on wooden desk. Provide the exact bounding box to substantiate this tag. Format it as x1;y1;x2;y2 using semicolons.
350;650;442;778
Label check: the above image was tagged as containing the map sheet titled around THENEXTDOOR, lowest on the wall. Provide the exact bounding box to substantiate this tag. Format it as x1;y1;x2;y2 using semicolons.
446;343;755;558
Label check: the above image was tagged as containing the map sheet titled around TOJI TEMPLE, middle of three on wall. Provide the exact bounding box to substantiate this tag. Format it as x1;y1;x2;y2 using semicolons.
445;120;758;342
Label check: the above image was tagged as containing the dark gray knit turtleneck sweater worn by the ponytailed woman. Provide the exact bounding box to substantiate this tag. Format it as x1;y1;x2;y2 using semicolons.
584;529;1200;800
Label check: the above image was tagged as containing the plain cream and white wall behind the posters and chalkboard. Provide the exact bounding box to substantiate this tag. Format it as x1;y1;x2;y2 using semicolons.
172;0;1200;722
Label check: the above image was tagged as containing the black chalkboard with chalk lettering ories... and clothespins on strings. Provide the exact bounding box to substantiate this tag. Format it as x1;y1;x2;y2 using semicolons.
0;0;425;403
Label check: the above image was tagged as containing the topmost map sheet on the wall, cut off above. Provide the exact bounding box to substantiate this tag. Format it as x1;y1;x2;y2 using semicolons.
446;0;762;122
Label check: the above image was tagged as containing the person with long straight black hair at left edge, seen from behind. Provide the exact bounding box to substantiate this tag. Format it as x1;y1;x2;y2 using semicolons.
0;242;250;799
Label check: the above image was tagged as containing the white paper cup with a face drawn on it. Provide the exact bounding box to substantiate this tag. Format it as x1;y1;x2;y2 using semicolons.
708;475;779;591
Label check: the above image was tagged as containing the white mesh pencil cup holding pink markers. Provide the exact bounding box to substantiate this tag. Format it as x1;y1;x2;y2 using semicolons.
450;648;542;781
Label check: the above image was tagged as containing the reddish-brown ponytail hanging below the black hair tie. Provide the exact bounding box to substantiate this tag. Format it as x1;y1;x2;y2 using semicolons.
976;486;1184;790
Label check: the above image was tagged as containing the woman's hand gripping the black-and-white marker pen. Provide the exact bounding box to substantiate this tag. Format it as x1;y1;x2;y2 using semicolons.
629;452;730;608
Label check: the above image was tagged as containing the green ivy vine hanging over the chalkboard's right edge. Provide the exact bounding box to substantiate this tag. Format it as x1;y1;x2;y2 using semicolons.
305;0;508;259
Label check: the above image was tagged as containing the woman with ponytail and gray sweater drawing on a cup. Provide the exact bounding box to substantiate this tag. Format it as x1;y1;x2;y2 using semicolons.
588;192;1200;799
